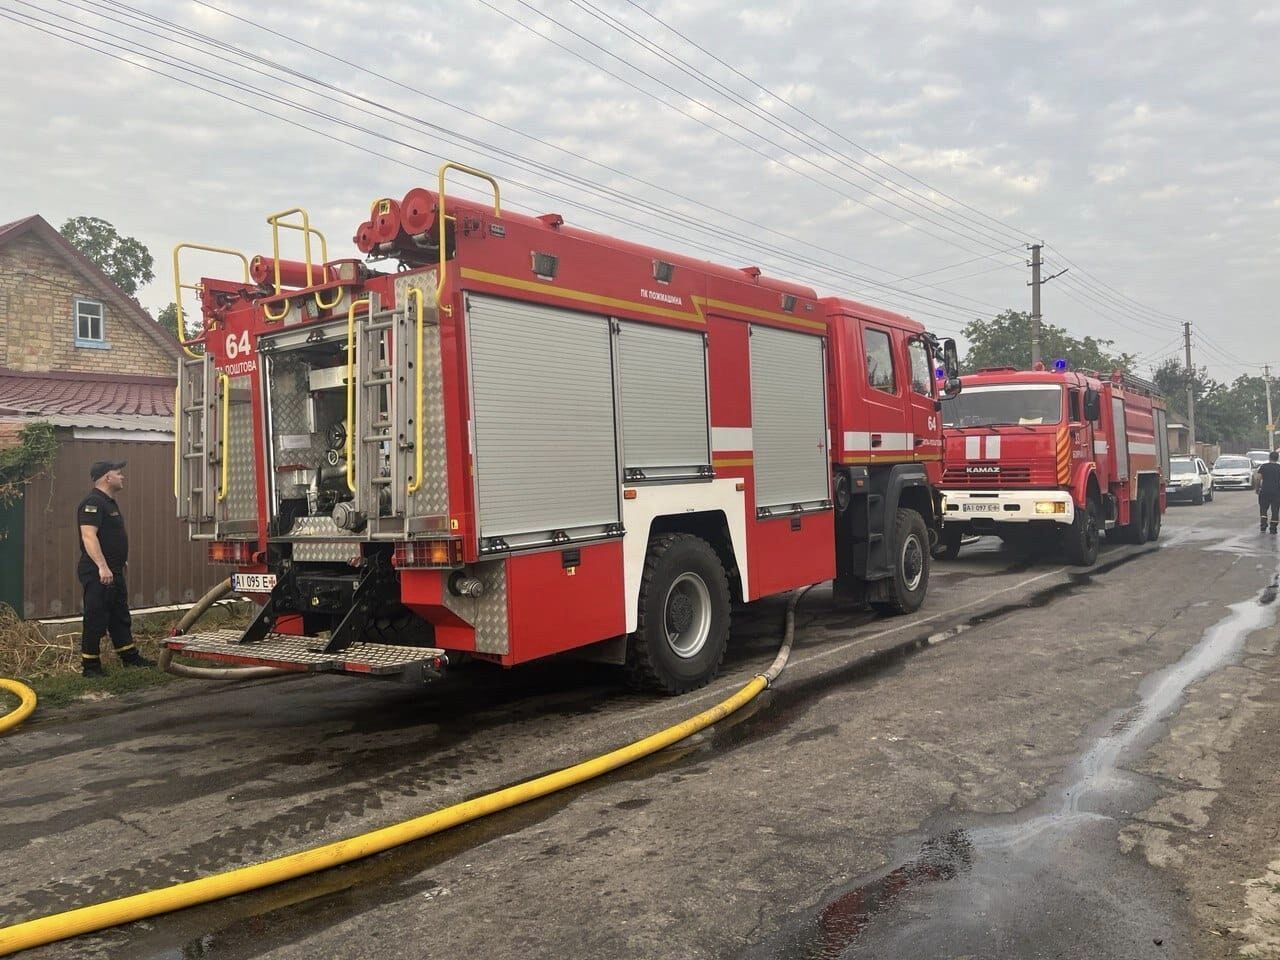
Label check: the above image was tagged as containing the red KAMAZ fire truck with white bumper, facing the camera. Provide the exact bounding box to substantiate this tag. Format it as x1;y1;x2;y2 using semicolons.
941;361;1169;566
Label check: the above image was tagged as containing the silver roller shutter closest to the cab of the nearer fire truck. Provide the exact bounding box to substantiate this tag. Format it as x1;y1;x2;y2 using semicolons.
751;326;831;508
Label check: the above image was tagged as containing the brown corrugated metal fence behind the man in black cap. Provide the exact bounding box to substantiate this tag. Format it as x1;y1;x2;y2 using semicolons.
22;430;228;620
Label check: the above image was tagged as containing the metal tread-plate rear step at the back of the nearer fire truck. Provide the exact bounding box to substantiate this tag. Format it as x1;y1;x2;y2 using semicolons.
165;630;449;682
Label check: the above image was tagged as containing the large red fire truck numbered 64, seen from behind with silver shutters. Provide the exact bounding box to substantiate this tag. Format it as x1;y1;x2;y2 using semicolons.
169;165;955;692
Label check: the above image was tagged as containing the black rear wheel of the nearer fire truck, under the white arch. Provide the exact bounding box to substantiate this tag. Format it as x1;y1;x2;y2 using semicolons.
626;534;730;695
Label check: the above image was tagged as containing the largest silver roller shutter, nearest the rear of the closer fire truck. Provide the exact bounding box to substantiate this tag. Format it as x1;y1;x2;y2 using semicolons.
467;294;618;538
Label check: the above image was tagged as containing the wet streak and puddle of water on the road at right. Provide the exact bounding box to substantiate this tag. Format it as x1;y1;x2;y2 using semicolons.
744;573;1280;960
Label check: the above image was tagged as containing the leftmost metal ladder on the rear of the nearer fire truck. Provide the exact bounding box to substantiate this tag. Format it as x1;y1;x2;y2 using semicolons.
174;353;219;539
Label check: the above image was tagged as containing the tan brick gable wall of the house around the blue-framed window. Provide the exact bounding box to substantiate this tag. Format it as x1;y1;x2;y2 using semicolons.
0;233;175;378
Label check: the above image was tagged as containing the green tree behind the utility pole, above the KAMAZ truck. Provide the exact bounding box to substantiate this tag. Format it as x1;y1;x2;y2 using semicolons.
963;310;1134;374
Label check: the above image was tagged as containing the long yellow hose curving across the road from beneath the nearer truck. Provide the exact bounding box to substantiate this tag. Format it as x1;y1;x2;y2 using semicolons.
0;591;805;956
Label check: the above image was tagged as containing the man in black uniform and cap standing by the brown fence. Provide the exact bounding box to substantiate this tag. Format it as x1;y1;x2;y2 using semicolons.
76;460;154;677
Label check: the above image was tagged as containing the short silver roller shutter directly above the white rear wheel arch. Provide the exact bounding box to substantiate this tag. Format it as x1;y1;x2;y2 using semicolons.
618;323;710;475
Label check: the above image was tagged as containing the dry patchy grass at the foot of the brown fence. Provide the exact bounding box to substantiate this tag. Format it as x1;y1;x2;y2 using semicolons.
0;603;247;716
